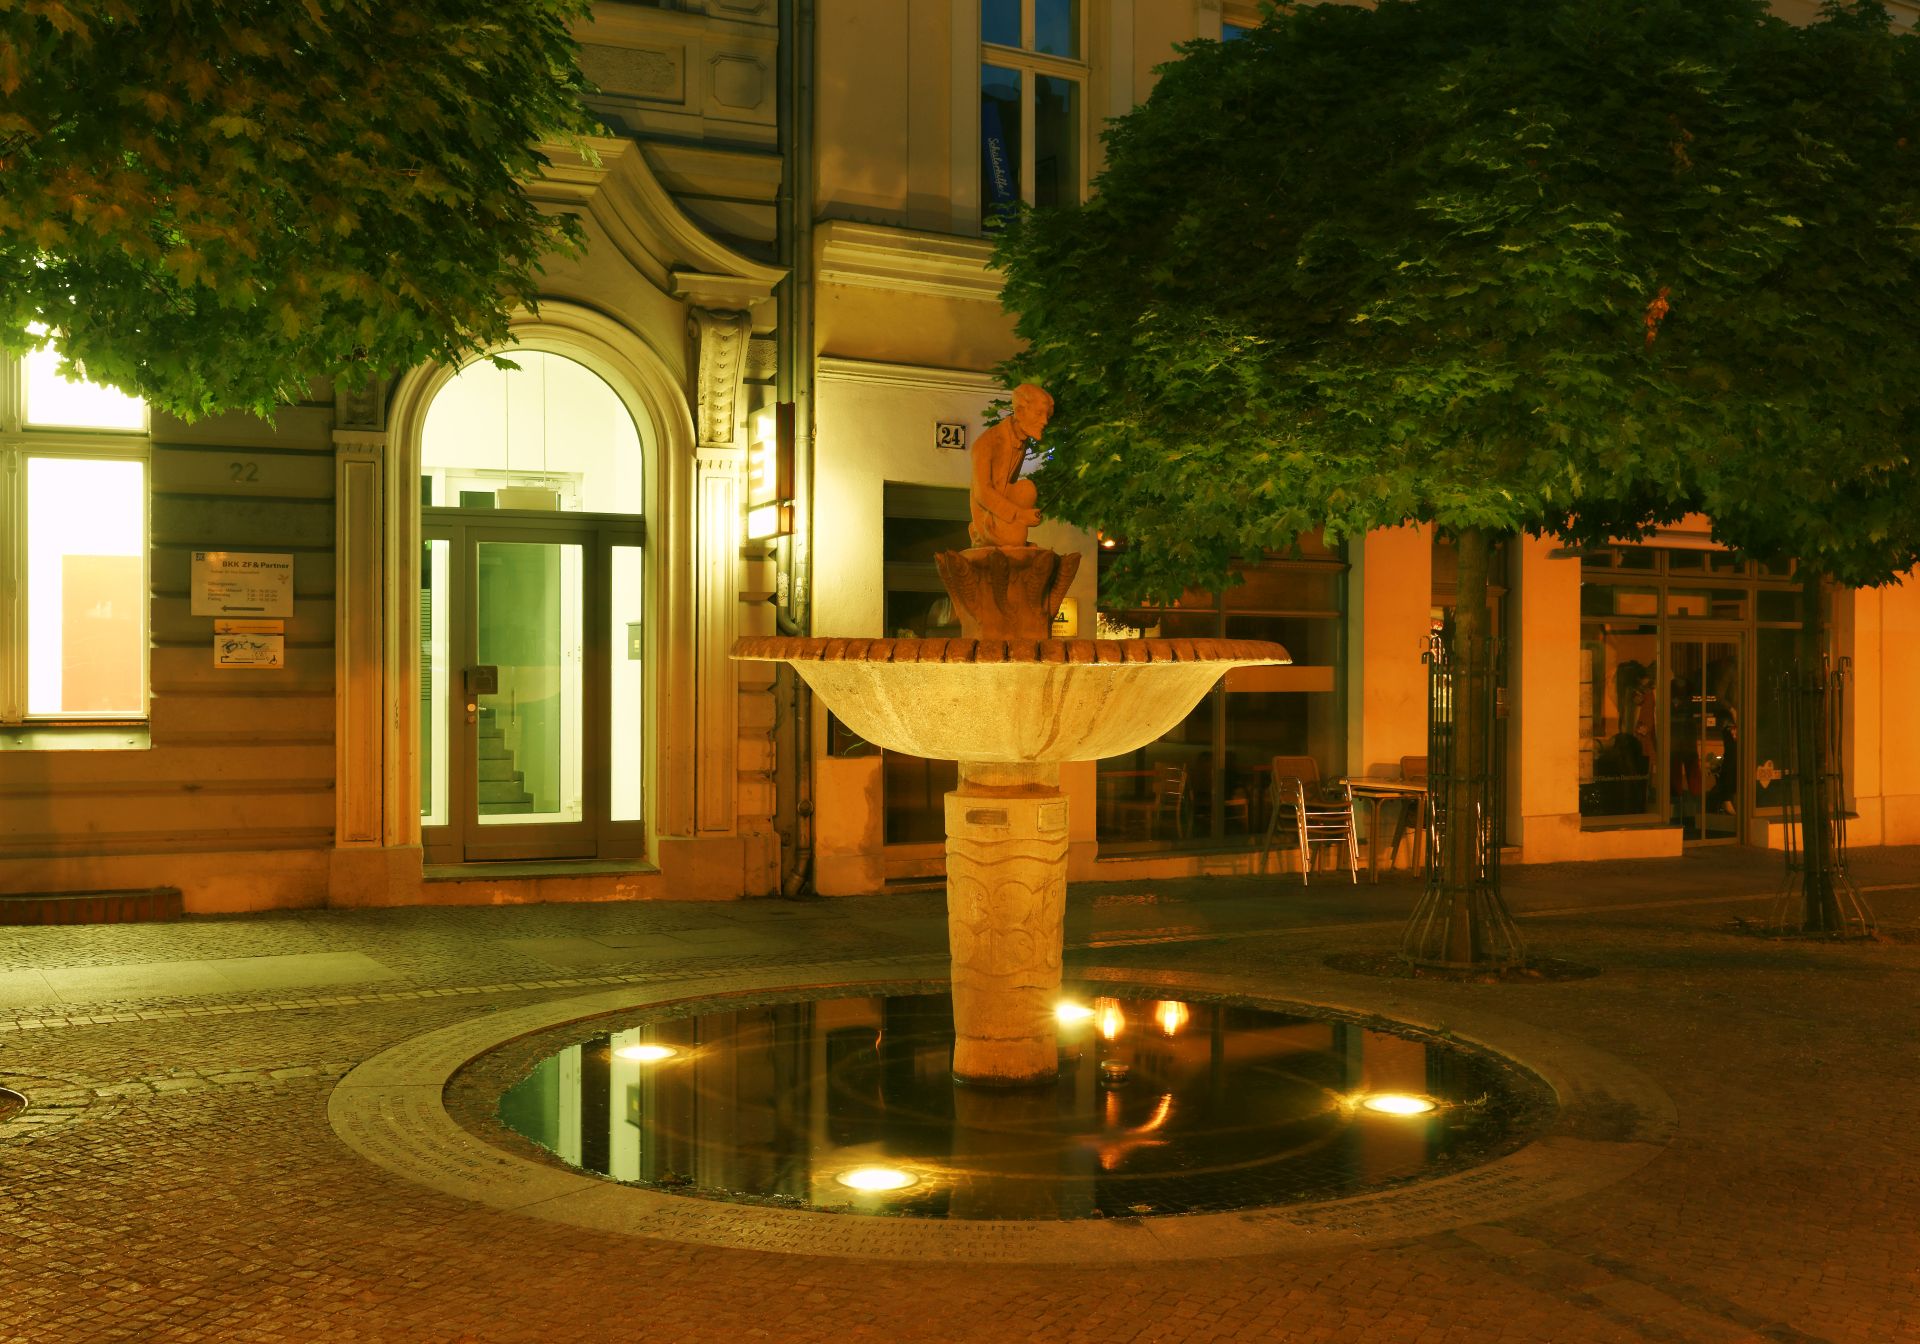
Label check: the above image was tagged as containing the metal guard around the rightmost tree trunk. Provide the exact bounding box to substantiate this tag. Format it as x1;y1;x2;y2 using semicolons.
1768;659;1874;939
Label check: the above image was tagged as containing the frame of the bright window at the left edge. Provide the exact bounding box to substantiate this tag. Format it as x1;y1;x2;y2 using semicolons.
0;345;154;728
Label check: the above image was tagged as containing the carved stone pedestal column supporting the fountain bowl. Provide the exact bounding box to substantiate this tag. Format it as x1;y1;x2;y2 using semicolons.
947;760;1068;1087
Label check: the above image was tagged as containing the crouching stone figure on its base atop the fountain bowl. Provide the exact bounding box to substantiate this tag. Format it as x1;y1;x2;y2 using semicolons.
933;382;1079;639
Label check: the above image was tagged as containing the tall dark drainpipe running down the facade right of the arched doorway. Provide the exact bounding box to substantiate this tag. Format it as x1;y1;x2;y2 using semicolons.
774;0;814;899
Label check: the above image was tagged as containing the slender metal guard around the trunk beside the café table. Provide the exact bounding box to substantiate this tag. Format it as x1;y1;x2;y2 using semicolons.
1400;634;1526;970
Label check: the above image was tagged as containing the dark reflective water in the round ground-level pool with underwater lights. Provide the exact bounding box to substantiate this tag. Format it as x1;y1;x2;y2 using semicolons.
499;995;1546;1219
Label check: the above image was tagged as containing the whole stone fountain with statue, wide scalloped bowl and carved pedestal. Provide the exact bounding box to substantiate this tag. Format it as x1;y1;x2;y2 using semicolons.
733;384;1290;1087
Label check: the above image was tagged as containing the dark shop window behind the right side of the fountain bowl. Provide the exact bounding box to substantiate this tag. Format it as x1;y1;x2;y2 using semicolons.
1096;538;1346;852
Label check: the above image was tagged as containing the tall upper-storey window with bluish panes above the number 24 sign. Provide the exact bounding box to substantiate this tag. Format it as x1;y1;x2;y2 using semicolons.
979;0;1087;221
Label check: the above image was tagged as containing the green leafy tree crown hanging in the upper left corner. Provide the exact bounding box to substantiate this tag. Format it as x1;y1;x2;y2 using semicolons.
0;0;593;417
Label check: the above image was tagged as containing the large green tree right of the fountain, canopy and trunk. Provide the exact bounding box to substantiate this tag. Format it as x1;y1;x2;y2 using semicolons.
998;0;1920;964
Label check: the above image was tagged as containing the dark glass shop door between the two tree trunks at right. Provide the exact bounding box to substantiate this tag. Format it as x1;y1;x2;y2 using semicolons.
1667;634;1747;843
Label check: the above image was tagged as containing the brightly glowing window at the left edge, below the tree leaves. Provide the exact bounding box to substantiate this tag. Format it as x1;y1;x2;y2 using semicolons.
0;348;148;724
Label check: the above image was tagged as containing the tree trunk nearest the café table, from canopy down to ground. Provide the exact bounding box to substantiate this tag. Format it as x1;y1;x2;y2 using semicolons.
1402;528;1524;968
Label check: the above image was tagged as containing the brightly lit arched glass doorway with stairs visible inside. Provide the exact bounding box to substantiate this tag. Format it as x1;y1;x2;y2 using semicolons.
415;348;651;862
